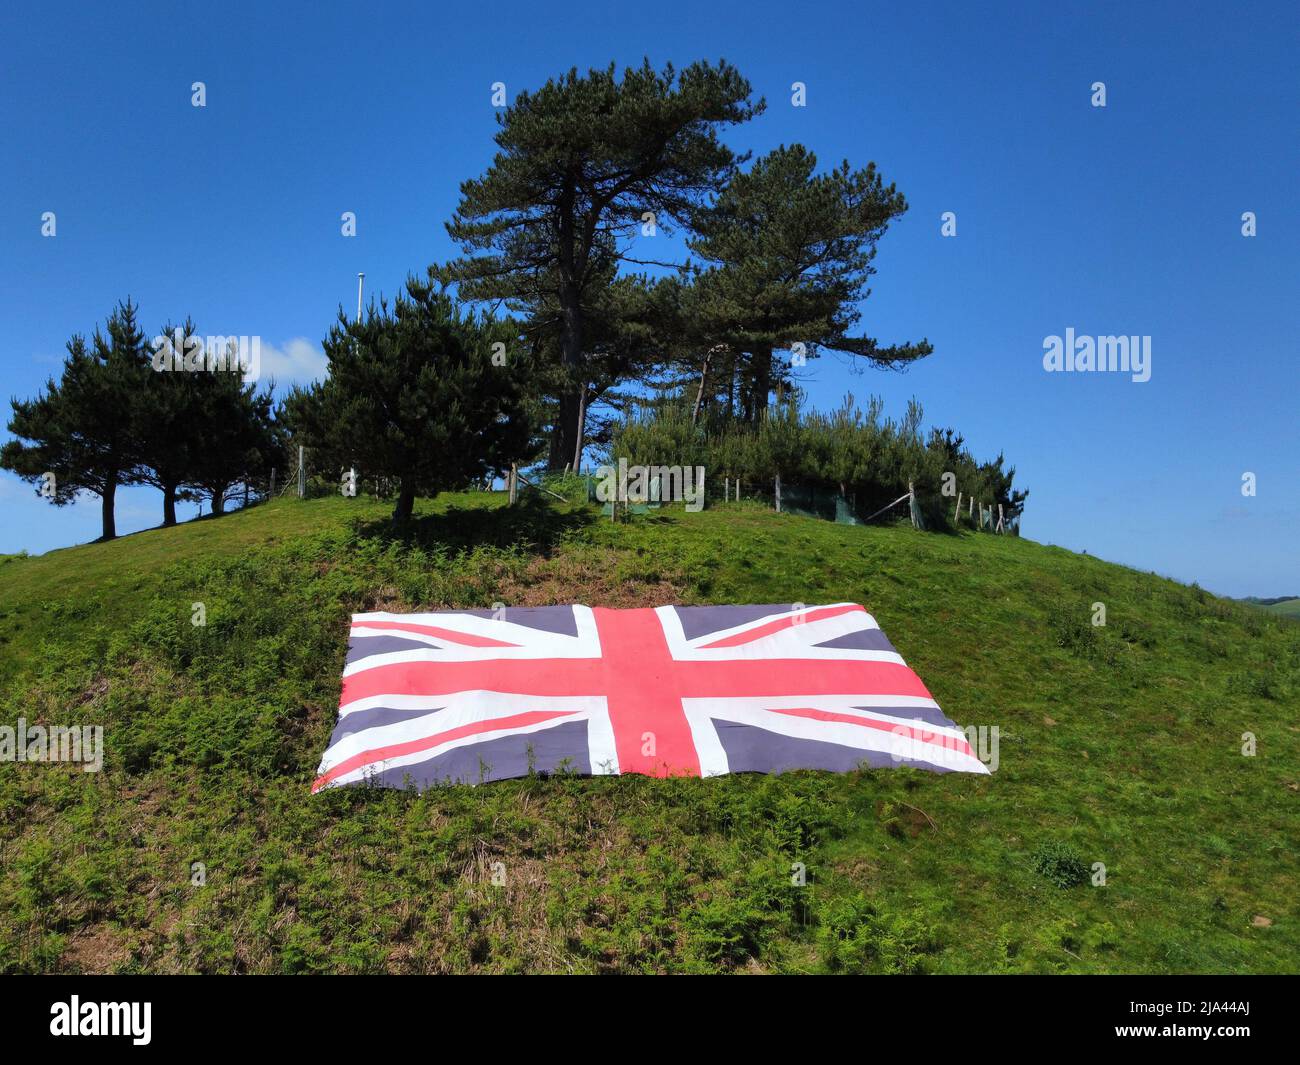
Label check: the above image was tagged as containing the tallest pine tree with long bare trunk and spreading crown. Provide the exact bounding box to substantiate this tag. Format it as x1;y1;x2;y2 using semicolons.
442;60;763;468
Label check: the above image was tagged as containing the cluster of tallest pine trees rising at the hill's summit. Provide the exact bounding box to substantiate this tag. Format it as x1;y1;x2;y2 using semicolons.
434;61;932;469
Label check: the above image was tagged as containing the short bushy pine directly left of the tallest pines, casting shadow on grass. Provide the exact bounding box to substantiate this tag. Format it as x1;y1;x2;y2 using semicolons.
285;280;533;521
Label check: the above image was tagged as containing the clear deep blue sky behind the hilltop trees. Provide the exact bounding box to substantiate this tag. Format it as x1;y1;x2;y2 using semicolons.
0;0;1300;596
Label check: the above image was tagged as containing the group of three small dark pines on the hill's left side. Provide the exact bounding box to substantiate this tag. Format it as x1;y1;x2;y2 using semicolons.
0;299;283;540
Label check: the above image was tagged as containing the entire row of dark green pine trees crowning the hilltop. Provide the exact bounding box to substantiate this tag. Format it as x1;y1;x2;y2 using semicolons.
0;61;1023;537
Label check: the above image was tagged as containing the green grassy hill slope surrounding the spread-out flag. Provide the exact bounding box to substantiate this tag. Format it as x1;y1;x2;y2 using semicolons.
0;494;1300;973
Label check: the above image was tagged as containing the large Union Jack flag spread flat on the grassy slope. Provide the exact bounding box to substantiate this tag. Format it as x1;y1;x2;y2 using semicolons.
312;603;988;791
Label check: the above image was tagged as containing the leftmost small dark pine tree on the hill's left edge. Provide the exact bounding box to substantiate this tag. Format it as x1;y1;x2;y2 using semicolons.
0;299;151;540
